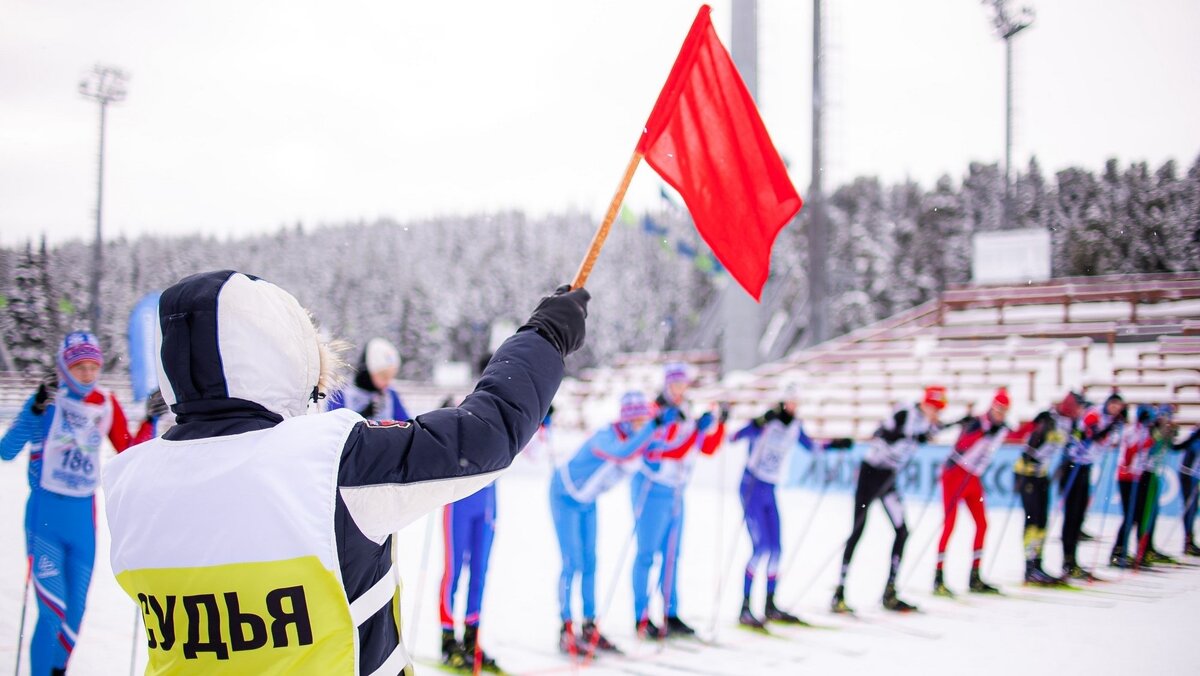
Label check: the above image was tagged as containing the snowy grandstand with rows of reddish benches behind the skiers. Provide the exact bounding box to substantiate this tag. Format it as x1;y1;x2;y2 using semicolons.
560;273;1200;438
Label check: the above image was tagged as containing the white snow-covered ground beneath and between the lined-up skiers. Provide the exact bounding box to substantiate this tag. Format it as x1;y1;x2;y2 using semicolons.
0;425;1200;676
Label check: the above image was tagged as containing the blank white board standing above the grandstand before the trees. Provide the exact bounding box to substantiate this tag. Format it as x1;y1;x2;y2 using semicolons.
971;228;1050;285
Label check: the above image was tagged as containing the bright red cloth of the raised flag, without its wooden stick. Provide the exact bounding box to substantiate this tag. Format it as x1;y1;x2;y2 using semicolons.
637;5;802;300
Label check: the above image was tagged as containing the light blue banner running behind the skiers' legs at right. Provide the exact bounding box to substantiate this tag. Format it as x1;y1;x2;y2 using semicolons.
784;444;1183;516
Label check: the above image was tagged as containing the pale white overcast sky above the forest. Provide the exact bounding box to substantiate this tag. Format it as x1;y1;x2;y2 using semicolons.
0;0;1200;245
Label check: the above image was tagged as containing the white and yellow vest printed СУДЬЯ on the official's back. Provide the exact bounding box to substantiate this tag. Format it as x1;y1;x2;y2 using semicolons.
104;409;409;675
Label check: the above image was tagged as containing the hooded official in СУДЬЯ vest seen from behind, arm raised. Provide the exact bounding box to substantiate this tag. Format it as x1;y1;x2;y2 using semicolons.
103;270;588;675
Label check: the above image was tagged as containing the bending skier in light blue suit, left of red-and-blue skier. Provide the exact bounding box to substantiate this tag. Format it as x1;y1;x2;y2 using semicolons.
550;391;671;654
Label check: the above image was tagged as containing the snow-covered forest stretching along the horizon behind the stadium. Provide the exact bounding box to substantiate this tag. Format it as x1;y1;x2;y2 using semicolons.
0;158;1200;379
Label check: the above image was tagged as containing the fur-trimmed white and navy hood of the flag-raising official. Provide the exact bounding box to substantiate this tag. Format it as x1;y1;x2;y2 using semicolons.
155;270;338;418
